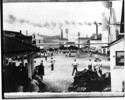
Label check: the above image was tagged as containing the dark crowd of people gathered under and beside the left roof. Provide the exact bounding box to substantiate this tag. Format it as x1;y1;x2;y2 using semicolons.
3;61;45;92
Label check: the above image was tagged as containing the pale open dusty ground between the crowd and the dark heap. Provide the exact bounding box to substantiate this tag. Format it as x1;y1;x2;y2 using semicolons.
35;54;110;92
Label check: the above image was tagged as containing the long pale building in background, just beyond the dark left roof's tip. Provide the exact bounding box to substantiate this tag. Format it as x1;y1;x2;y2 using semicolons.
33;34;67;49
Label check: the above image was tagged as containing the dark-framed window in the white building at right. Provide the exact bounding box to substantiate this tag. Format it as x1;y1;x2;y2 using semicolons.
116;51;124;66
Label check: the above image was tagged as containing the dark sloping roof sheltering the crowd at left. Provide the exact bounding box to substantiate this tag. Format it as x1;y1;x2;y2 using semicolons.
2;35;39;57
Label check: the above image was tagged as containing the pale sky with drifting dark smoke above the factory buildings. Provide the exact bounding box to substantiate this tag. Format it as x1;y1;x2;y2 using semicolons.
3;0;122;41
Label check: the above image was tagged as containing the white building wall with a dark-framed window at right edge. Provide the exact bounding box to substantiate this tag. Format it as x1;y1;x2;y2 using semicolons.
109;38;125;92
